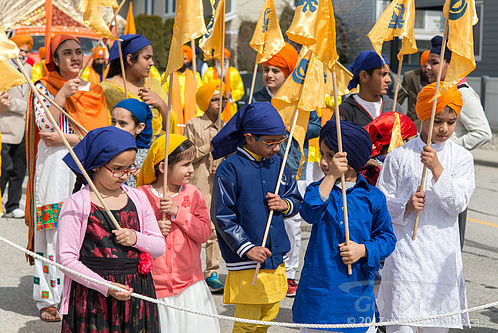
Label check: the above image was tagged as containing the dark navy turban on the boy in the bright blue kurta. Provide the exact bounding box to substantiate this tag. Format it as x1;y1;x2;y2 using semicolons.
320;119;372;171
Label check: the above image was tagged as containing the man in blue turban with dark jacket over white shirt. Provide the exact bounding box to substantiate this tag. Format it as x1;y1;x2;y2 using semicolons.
339;51;405;127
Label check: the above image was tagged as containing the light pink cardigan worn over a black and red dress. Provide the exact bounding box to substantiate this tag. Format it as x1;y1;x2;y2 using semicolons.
57;185;166;314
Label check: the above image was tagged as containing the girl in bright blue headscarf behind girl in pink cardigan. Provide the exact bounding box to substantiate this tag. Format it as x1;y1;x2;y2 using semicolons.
111;98;152;187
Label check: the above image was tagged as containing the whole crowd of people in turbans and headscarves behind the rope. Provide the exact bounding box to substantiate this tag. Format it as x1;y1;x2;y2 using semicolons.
0;28;491;333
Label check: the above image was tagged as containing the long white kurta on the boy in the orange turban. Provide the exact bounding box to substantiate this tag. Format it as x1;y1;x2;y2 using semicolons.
377;137;475;328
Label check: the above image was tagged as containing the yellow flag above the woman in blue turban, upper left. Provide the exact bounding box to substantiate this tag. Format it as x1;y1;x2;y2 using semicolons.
78;0;118;39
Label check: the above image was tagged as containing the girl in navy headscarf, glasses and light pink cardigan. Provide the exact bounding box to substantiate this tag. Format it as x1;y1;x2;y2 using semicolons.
54;126;165;333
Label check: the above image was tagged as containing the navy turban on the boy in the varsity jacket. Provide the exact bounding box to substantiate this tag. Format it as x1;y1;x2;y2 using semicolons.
211;103;285;160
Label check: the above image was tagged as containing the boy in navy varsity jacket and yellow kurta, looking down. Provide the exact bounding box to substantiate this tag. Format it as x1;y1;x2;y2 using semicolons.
211;103;302;332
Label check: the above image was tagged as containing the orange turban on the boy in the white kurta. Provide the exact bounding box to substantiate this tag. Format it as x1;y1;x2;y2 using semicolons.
415;82;462;121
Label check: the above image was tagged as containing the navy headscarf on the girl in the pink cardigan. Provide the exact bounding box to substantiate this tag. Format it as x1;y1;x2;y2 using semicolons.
62;126;137;184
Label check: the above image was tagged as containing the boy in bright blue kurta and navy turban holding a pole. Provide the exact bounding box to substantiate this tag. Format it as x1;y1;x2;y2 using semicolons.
292;120;396;332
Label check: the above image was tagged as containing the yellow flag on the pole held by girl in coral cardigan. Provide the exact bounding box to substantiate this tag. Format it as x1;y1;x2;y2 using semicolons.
161;0;207;77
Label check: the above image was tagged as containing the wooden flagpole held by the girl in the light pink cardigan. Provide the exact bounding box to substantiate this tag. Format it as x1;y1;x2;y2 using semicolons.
12;58;121;230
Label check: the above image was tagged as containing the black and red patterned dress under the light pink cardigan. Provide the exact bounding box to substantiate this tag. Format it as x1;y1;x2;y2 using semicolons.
62;199;159;333
